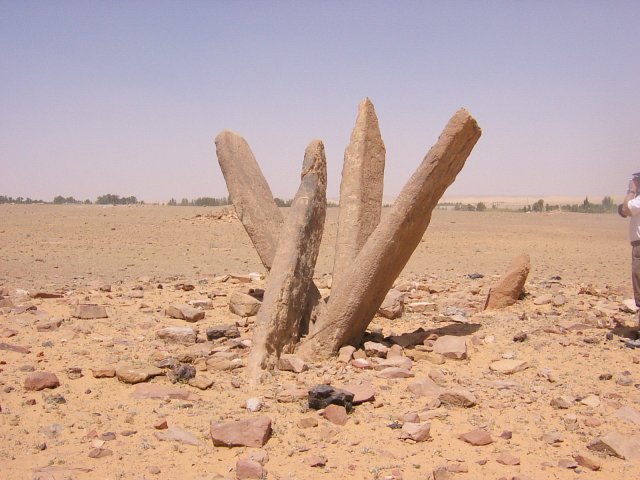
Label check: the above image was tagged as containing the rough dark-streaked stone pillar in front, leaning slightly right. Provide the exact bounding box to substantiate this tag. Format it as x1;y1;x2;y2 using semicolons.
248;140;327;381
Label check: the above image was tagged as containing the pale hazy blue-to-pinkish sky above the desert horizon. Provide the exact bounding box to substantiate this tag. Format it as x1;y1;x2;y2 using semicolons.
0;0;640;201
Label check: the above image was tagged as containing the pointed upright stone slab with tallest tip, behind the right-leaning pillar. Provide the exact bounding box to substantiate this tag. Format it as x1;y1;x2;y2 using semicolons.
333;98;386;288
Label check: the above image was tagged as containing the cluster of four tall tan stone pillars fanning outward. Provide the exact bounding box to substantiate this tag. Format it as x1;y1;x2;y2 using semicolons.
216;99;480;379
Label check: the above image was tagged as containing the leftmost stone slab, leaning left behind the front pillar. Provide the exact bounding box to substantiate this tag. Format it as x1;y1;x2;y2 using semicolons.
216;130;283;269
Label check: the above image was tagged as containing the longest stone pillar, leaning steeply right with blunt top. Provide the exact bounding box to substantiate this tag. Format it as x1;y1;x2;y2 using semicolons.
298;109;481;359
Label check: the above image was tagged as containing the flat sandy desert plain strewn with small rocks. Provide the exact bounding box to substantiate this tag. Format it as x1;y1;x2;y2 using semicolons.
0;205;640;480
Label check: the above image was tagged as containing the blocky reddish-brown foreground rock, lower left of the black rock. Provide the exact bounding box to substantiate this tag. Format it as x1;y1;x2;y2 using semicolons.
211;416;271;447
